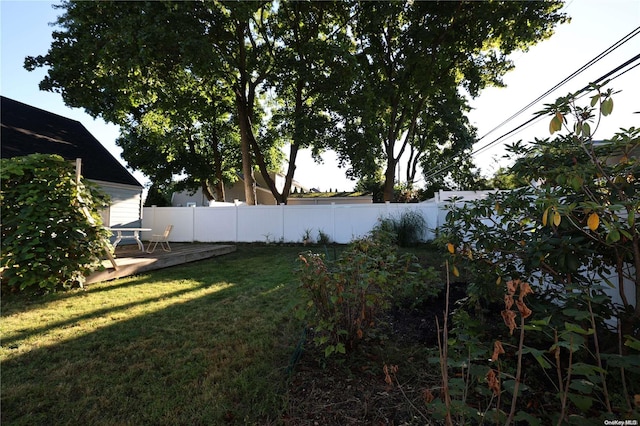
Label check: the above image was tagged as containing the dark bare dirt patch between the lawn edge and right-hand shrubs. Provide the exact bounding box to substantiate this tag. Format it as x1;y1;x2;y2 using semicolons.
283;284;466;425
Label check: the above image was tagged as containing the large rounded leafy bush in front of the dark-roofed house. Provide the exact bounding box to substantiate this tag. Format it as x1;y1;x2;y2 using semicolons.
0;154;109;291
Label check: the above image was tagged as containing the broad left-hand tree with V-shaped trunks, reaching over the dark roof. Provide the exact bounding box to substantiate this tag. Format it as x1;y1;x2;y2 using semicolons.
27;1;356;204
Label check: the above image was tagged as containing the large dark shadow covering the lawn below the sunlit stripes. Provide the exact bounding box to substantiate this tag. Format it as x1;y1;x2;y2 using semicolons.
1;253;298;425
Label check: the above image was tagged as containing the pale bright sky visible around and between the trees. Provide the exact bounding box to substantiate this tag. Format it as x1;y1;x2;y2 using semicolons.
0;0;640;191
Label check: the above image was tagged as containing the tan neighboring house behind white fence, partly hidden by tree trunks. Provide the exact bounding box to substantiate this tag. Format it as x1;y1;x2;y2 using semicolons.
171;172;309;207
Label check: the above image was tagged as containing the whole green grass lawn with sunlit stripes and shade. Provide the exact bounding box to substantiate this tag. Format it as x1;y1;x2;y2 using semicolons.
0;246;310;425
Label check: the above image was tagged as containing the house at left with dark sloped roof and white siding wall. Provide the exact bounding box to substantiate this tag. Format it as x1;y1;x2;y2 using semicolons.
0;96;143;227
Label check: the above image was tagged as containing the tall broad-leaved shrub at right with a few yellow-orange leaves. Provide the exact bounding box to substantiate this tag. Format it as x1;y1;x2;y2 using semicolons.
432;87;640;424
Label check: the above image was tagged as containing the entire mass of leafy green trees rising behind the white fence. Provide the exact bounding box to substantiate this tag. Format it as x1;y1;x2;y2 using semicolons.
25;1;566;204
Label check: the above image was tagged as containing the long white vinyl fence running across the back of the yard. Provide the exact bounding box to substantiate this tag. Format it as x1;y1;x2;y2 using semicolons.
142;203;446;244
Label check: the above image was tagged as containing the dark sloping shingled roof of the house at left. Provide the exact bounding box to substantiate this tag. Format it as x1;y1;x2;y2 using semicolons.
0;96;142;187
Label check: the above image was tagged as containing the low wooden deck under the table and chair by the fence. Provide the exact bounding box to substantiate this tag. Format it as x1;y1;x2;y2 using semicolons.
86;243;236;284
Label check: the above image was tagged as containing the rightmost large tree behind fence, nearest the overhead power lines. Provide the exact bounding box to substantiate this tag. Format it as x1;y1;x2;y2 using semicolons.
335;1;565;200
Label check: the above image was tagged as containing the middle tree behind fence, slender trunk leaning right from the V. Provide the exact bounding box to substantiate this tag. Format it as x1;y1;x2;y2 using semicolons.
265;2;354;202
